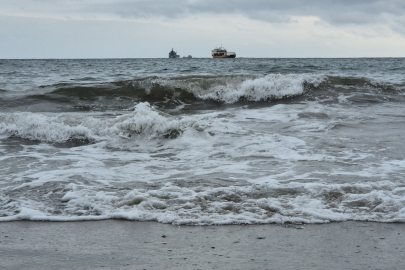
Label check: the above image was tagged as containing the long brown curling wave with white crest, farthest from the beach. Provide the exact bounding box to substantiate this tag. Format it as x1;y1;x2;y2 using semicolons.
2;74;405;111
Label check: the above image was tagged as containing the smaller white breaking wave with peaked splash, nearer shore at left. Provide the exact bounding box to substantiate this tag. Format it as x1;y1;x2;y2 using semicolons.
0;103;207;143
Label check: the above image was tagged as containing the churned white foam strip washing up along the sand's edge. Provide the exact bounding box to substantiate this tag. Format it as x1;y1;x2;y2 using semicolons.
0;182;405;225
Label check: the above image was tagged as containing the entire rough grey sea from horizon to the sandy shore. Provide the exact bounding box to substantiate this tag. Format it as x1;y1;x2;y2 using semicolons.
0;58;405;225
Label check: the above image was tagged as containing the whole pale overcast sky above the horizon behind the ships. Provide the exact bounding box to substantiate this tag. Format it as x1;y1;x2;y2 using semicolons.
0;0;405;58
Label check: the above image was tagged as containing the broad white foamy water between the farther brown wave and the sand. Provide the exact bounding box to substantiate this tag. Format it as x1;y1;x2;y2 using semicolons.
0;92;405;225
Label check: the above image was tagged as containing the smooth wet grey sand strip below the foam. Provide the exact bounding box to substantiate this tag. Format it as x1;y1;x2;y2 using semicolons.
0;220;405;269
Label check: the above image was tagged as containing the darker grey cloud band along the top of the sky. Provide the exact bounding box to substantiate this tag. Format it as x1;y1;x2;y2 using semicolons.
0;0;405;31
